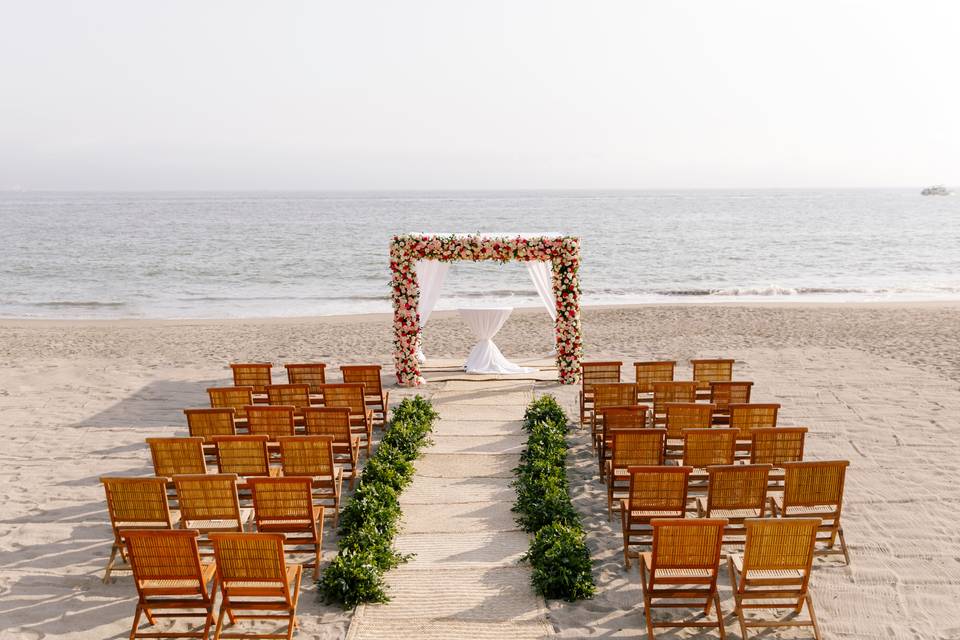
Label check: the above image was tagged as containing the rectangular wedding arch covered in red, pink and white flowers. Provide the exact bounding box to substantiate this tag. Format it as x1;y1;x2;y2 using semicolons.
390;234;583;386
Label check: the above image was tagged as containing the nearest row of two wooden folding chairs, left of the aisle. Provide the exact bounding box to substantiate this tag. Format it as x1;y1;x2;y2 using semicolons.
125;529;303;640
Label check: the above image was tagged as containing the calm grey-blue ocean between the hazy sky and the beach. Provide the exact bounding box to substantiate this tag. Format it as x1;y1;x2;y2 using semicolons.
0;190;960;318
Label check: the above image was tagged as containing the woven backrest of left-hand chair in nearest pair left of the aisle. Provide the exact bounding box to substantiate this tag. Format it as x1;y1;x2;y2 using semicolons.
124;529;213;601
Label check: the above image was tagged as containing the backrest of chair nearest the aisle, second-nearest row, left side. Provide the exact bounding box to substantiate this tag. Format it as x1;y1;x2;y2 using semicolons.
249;476;314;531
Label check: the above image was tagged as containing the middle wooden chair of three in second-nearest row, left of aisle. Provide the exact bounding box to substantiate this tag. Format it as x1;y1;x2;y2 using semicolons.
173;473;253;533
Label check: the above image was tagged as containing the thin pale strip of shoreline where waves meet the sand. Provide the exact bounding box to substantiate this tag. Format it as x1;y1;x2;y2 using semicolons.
0;299;960;328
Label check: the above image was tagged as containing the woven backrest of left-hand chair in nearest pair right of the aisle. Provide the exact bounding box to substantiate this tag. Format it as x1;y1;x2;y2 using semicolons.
648;518;727;587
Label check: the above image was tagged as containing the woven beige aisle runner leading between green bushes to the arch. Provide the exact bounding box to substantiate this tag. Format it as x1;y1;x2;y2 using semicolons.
347;381;552;640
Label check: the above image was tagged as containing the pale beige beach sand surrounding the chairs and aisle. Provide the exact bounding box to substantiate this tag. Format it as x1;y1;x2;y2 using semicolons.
0;303;960;638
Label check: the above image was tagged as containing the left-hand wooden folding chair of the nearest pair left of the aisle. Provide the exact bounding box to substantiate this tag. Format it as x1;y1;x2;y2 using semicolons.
126;529;217;640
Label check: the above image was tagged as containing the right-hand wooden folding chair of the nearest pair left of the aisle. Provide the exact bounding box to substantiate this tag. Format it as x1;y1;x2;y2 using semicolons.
210;533;303;640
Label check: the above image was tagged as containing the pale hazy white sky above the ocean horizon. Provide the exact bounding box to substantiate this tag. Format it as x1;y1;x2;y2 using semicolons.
0;0;960;189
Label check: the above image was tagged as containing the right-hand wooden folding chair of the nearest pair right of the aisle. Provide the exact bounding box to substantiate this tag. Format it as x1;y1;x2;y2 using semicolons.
727;518;820;640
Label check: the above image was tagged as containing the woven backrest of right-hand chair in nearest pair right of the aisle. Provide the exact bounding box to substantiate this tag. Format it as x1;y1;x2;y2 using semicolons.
737;518;821;593
